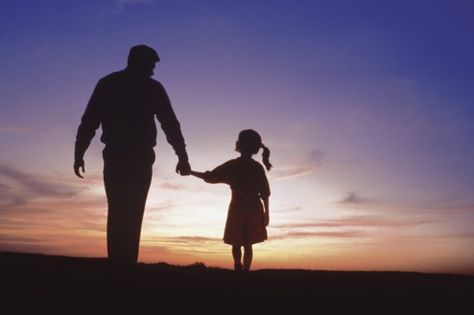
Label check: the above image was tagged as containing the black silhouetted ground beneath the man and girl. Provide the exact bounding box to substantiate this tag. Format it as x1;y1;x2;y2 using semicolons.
0;253;474;315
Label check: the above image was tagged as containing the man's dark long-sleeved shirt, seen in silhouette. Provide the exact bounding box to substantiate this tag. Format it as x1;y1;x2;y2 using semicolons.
77;69;185;160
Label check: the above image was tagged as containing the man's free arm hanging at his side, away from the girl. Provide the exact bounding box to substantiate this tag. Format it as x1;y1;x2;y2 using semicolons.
74;81;103;178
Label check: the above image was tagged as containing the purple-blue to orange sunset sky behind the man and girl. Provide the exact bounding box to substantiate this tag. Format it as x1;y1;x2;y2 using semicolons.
0;0;474;274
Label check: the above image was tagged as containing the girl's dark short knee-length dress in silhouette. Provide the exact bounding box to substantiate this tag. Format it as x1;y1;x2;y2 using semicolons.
204;157;270;246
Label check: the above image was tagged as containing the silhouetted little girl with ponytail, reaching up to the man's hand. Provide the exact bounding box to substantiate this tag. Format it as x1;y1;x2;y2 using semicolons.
191;129;272;271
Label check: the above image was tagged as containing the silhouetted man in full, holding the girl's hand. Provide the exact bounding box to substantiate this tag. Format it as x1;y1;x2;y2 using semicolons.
74;45;191;265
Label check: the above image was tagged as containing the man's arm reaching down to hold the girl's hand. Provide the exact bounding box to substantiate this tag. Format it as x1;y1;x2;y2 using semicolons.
156;83;191;175
